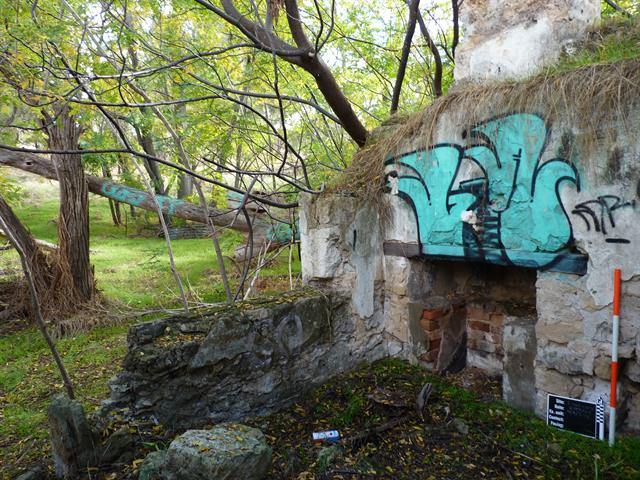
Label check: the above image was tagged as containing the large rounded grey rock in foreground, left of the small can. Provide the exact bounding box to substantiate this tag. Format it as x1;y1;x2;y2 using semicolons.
139;423;272;480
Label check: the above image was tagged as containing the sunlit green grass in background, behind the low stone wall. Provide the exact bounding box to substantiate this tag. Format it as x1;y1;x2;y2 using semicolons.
0;197;300;309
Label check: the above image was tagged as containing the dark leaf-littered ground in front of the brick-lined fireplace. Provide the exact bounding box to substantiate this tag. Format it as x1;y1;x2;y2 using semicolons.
250;359;640;480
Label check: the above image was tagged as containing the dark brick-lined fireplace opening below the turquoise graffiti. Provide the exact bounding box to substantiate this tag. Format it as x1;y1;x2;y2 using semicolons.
420;260;537;410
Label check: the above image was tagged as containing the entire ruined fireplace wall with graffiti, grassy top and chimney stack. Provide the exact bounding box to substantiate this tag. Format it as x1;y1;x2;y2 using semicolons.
300;0;640;430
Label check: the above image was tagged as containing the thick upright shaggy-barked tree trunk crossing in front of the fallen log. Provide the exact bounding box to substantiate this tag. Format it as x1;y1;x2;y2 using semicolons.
43;106;95;301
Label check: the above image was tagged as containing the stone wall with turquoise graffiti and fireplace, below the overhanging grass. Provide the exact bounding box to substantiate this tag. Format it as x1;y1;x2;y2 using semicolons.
301;100;640;429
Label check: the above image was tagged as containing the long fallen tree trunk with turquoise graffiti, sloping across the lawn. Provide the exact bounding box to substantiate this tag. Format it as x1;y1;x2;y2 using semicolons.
0;149;249;232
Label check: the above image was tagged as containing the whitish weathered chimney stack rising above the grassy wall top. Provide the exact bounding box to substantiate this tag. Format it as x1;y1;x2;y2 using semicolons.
454;0;600;81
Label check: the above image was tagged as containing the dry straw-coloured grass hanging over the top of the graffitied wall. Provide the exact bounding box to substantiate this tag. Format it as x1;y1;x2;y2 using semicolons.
333;59;640;204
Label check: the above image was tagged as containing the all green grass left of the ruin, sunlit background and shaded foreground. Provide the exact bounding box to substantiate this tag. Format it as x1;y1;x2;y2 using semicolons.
0;191;300;478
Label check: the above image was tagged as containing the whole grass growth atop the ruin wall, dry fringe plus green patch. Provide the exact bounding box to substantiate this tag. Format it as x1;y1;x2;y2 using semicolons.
333;18;640;205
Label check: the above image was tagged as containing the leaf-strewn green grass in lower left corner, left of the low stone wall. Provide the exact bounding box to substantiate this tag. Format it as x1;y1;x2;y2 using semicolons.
0;323;133;479
